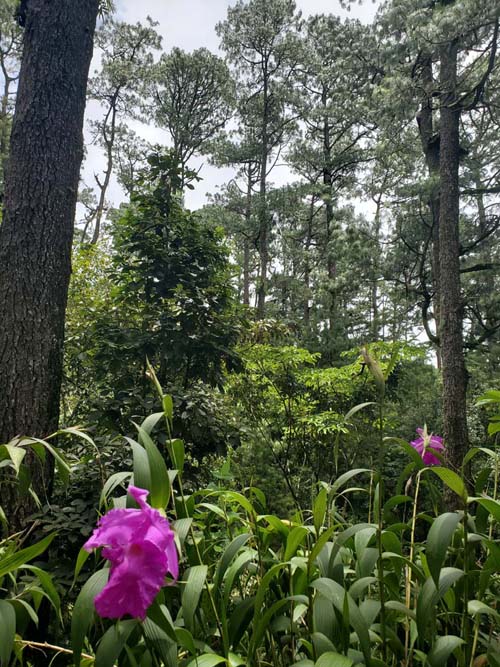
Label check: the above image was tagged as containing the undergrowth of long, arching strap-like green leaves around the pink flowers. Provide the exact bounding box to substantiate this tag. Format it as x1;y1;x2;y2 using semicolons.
0;377;500;667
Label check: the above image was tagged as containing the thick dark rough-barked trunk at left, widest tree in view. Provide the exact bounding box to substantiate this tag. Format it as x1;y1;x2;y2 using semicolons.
0;0;99;526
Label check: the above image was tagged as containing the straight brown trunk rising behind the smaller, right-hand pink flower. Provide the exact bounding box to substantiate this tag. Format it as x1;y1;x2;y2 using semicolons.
439;41;468;486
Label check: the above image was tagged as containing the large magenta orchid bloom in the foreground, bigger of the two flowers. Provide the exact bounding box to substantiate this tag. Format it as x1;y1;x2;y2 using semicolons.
83;485;179;620
